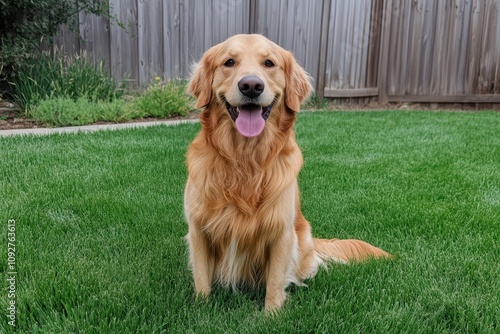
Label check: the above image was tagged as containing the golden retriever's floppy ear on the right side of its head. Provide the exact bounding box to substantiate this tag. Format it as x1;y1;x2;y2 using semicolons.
283;51;313;112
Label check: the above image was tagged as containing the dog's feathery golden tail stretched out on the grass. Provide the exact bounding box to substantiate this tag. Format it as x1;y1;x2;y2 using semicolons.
313;238;392;263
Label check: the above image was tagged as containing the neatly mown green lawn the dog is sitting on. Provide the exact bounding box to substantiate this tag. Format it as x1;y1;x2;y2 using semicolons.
0;111;500;333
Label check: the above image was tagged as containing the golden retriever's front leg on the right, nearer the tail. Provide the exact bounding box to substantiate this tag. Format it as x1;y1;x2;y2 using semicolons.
264;231;297;311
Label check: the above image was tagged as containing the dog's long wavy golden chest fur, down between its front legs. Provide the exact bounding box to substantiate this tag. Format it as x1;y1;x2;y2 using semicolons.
185;134;302;286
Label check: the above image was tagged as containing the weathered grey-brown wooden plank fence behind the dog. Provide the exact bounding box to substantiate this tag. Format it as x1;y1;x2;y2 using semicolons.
56;0;500;103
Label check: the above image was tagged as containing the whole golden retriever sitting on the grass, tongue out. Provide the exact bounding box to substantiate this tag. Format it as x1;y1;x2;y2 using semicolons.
184;35;390;310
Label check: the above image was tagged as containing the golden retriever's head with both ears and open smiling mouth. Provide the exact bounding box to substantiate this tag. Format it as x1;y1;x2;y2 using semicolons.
187;35;312;137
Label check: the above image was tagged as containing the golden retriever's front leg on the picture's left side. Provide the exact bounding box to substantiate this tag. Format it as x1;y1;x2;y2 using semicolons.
187;228;214;297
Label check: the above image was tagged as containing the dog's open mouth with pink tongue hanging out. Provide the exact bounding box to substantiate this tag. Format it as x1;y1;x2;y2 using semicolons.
225;100;274;138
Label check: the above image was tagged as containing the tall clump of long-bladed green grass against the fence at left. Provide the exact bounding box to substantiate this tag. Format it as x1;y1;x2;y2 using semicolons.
14;50;123;114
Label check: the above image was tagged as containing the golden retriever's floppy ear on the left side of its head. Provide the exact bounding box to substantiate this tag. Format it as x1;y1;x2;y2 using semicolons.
186;48;215;108
